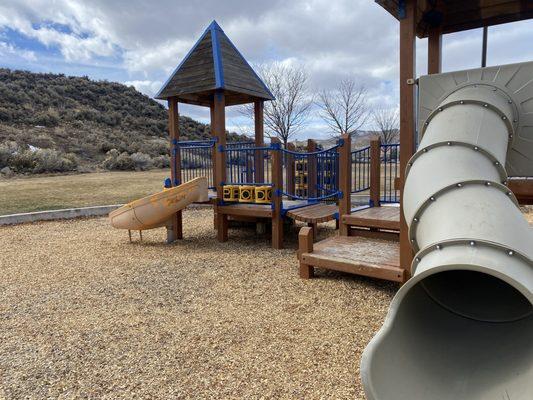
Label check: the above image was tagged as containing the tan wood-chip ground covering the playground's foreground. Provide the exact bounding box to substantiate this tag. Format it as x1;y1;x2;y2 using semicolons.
0;209;397;399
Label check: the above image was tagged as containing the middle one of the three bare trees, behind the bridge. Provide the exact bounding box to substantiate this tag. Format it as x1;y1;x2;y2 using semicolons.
317;79;368;136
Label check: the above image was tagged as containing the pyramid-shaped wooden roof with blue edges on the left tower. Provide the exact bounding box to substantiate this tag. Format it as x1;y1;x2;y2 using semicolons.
155;21;274;106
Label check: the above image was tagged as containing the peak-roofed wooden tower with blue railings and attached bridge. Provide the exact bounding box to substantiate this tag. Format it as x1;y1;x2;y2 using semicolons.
152;21;397;248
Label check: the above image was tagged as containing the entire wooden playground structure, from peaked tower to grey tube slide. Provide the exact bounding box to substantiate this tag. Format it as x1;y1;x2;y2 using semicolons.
104;0;533;400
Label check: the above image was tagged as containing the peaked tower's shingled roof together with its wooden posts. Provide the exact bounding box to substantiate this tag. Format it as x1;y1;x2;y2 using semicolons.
156;21;274;241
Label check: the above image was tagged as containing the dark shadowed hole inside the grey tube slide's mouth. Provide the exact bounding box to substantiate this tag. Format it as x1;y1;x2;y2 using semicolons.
420;270;533;322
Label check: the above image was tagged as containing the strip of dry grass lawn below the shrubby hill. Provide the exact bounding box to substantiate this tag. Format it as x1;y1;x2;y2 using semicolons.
0;170;170;215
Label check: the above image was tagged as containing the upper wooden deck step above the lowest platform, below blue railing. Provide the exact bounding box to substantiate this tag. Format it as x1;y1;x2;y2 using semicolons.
341;206;400;231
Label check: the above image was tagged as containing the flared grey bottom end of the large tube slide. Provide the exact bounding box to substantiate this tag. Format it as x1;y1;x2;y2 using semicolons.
365;282;533;400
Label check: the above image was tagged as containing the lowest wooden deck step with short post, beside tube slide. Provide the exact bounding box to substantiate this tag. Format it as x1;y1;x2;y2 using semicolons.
298;228;405;282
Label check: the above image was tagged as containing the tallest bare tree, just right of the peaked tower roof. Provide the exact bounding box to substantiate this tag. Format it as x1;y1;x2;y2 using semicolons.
240;62;313;147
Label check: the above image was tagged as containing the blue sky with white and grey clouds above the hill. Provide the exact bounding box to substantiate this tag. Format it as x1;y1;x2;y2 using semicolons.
0;0;533;137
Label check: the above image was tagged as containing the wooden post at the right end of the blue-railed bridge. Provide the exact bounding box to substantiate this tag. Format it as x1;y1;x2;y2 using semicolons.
337;135;352;236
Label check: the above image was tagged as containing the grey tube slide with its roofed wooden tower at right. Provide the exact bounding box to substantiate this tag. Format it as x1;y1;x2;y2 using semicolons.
361;0;533;400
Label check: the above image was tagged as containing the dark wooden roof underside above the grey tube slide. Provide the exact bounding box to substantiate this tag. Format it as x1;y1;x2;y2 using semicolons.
375;0;533;38
